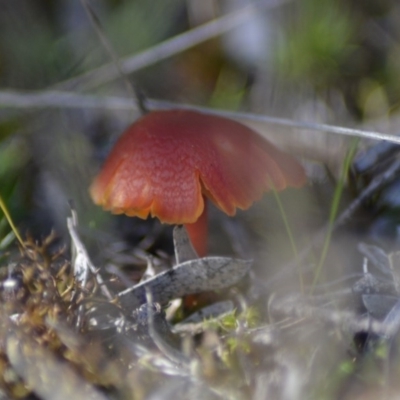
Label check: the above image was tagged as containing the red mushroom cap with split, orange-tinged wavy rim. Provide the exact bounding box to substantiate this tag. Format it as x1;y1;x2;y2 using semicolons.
90;110;306;224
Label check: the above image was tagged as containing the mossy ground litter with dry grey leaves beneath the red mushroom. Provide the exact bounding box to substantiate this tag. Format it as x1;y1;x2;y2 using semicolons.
0;212;400;400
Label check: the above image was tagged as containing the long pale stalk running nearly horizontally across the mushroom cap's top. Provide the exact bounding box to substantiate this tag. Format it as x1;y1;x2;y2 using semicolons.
0;90;400;144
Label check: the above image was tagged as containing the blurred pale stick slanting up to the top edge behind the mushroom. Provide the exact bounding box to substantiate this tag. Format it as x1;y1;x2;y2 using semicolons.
53;0;292;90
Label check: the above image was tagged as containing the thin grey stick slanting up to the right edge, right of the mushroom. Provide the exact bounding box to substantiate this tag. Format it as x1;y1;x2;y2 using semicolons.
267;159;400;285
